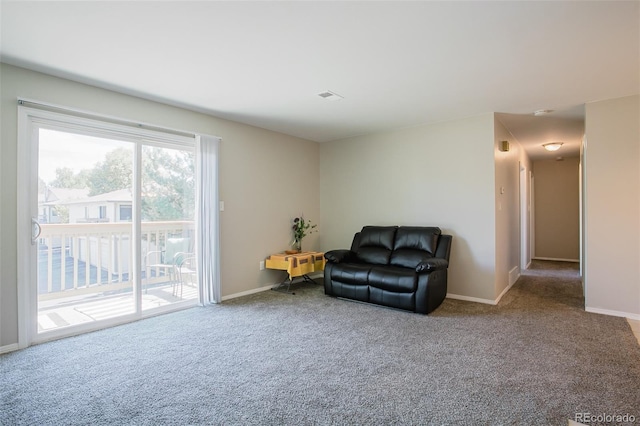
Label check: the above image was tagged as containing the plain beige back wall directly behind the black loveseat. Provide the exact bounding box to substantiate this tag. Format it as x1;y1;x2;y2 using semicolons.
320;114;496;301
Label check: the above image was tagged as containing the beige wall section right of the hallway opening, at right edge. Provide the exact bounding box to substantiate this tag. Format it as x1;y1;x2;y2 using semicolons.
583;95;640;319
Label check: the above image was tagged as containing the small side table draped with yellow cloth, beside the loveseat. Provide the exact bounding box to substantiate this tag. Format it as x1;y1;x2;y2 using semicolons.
265;251;325;294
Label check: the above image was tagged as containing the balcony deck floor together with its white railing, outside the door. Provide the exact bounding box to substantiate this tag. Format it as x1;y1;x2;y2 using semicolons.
37;221;198;332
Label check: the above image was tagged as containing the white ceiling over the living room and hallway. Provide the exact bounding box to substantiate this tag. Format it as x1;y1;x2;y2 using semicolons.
0;0;640;159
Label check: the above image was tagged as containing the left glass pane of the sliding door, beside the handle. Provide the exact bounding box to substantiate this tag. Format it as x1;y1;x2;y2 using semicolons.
36;128;135;333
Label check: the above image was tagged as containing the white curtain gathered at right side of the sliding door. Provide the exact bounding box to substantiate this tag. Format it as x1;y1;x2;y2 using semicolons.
196;135;221;305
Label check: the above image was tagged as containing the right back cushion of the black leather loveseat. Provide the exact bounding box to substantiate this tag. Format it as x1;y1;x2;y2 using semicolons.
389;226;441;270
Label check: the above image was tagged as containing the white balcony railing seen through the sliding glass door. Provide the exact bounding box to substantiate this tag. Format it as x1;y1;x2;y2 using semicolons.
38;221;193;301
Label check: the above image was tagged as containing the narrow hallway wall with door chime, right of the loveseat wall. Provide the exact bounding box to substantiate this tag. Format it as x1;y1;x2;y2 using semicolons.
494;115;528;298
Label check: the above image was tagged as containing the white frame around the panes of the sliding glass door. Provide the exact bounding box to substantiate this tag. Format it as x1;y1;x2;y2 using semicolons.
17;101;195;349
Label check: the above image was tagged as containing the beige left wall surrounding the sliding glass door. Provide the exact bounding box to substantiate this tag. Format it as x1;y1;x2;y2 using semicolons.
0;64;322;348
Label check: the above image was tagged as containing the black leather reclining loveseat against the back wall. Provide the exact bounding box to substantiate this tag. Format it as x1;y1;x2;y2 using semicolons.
324;226;452;314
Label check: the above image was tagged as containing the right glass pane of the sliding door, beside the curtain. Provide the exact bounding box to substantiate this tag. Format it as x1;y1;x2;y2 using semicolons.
140;145;198;311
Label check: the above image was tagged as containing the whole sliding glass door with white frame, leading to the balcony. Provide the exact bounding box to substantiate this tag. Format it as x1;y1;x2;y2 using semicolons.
21;105;198;342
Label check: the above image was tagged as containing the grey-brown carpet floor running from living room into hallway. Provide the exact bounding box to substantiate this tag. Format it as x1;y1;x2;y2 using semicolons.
0;262;640;425
